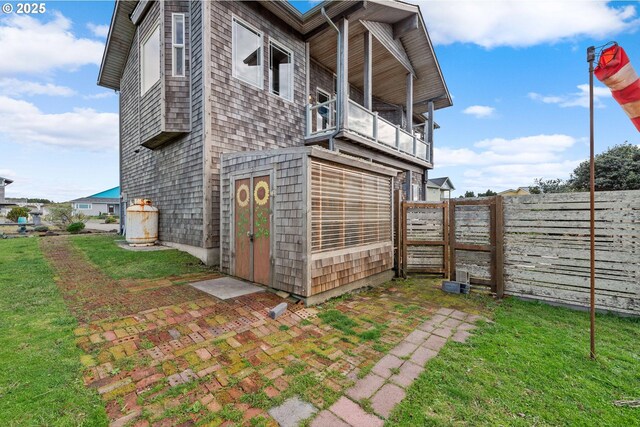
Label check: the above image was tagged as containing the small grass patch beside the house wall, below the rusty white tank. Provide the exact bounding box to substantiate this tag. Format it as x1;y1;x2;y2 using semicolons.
71;235;215;279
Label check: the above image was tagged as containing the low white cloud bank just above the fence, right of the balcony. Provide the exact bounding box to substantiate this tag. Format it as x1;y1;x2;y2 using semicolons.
434;134;581;192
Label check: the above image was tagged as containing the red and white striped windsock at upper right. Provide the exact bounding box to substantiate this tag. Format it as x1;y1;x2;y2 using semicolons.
594;44;640;131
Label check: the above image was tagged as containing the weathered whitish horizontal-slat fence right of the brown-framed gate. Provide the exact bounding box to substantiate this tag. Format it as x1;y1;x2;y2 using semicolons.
503;191;640;315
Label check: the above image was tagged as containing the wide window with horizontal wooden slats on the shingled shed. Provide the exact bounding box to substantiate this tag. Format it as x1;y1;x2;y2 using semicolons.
311;160;391;253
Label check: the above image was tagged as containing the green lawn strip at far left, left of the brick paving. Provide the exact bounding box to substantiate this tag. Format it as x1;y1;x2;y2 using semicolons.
0;238;107;426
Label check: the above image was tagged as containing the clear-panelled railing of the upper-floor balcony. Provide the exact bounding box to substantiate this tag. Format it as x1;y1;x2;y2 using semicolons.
306;99;432;164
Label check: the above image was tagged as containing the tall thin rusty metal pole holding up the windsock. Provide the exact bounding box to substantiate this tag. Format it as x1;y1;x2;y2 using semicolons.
587;46;596;359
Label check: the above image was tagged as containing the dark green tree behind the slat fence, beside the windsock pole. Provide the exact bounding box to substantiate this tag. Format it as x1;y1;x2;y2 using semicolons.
568;141;640;191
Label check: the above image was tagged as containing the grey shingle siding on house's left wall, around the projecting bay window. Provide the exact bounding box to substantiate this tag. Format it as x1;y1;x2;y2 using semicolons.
120;1;204;247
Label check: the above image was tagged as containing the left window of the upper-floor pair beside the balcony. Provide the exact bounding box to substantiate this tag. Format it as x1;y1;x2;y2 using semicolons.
232;18;263;89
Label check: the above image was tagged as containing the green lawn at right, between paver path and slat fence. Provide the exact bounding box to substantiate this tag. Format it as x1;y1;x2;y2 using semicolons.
387;299;640;426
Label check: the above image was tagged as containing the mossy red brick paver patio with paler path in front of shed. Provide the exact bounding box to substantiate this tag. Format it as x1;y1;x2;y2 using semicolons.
42;239;488;426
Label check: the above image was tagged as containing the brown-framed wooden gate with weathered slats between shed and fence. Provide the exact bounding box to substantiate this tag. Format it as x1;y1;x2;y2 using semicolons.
397;196;504;296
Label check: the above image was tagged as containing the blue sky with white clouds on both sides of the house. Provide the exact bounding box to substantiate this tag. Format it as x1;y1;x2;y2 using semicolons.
0;0;640;201
